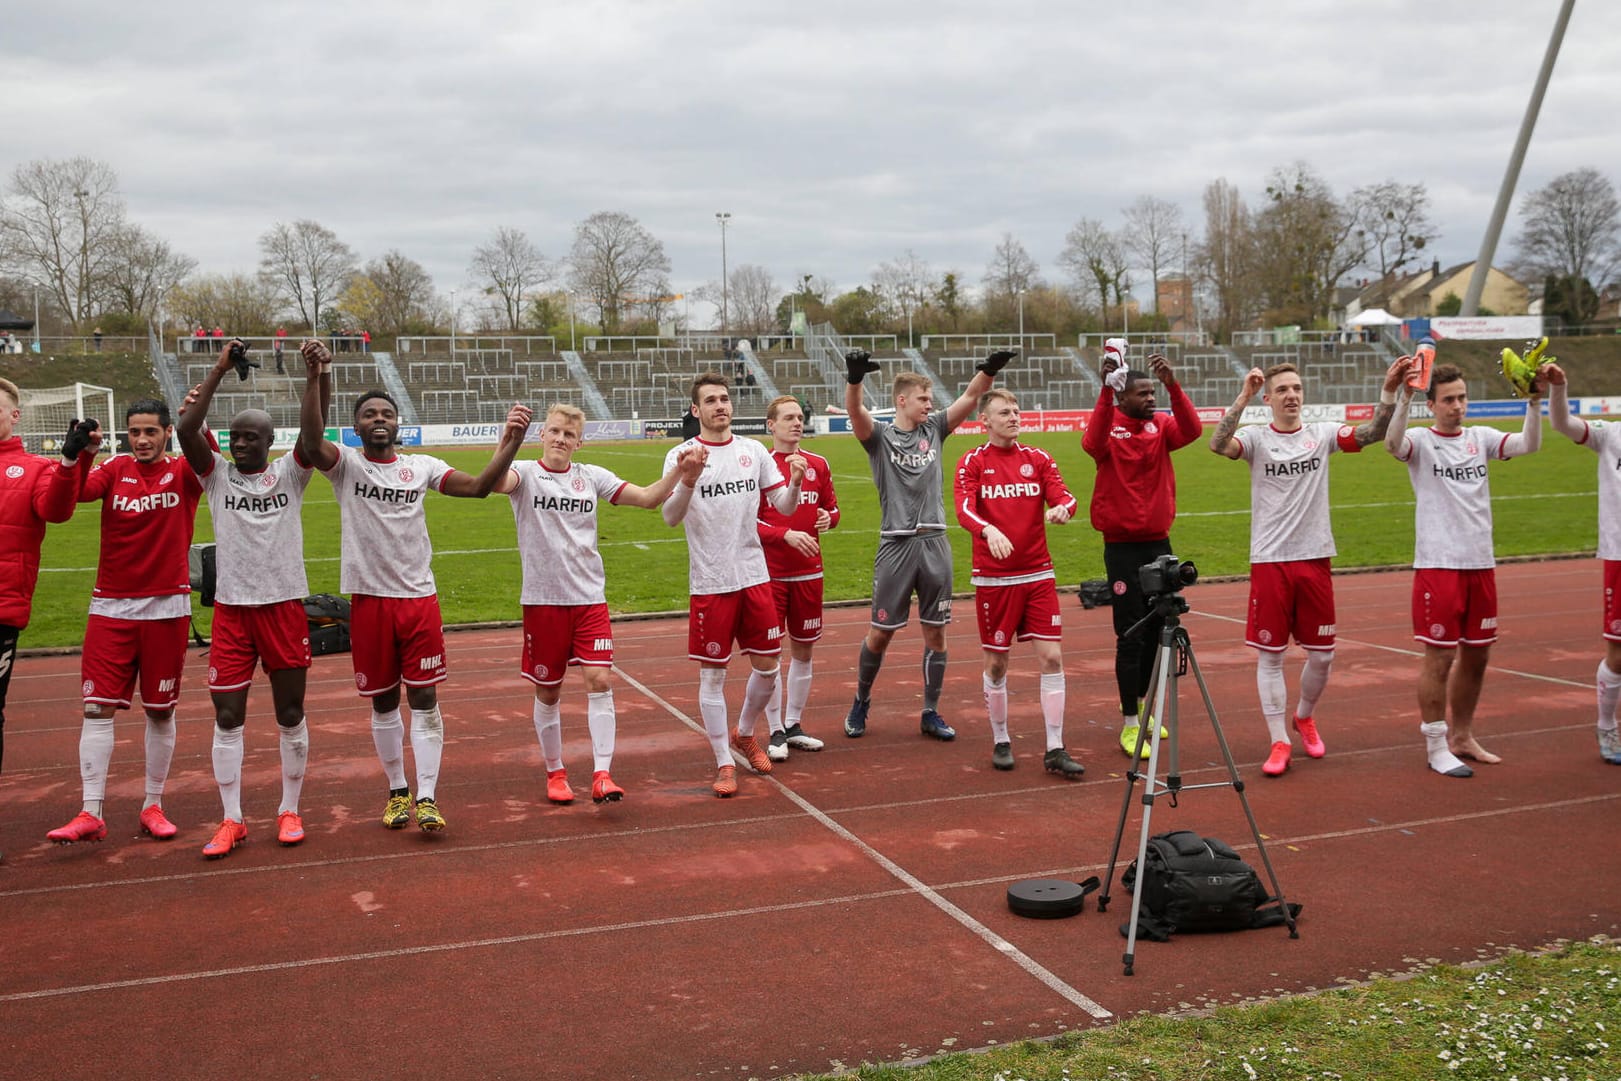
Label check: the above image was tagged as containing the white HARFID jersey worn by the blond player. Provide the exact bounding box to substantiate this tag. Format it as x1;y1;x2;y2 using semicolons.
507;460;626;605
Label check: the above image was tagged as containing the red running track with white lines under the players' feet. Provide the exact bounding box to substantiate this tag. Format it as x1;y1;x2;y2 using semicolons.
0;561;1621;1081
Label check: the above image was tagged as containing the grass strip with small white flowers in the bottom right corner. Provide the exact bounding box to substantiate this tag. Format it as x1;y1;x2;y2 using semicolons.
800;942;1621;1081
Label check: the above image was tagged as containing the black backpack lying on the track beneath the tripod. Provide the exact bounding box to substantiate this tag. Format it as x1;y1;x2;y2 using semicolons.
1120;830;1300;942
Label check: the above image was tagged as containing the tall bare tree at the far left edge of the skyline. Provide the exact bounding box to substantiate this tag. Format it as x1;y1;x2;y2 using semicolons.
0;157;123;324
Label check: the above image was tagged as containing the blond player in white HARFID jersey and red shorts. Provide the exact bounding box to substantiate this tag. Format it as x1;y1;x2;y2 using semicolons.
496;405;697;804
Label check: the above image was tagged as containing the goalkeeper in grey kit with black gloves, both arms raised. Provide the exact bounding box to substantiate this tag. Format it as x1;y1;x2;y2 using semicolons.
845;348;1018;741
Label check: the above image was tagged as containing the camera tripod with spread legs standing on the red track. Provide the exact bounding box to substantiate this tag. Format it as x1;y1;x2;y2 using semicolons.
1097;583;1300;976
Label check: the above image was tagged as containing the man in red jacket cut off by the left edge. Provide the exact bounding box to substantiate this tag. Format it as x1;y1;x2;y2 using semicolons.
0;379;99;862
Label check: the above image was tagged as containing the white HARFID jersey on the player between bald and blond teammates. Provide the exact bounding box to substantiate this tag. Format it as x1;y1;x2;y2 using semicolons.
326;447;451;596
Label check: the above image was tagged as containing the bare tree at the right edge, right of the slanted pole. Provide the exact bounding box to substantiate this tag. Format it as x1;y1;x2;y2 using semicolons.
1514;169;1621;290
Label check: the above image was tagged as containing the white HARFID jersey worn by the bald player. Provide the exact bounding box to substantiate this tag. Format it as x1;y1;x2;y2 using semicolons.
203;452;311;605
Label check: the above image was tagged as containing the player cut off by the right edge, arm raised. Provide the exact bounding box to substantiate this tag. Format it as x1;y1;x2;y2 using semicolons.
1540;363;1621;765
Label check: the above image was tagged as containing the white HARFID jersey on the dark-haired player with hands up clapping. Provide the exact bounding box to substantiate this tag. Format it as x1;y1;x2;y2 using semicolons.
665;436;786;596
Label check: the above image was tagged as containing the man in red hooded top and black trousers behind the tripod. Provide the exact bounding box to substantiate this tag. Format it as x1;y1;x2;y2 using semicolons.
1081;339;1201;758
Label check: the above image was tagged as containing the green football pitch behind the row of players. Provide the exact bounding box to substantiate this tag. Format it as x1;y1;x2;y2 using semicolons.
23;423;1598;647
